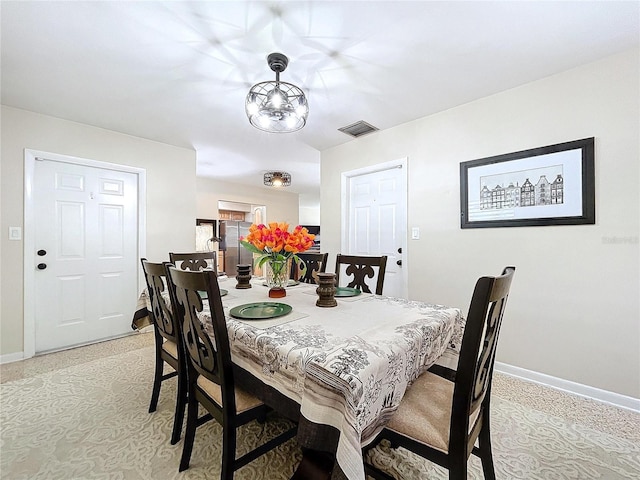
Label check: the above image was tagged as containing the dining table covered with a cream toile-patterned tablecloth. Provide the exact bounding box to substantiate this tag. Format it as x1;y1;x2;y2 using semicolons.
132;277;465;480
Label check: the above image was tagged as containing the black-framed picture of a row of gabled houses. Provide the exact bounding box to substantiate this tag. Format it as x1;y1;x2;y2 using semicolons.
460;137;596;228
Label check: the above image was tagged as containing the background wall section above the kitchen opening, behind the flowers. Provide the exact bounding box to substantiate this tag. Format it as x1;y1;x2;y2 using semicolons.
196;177;298;226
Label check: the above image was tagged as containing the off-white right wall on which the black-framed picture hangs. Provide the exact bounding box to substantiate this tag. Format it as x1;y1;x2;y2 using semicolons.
321;50;640;398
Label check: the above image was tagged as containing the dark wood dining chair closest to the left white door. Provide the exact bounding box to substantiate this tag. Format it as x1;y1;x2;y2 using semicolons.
141;258;187;445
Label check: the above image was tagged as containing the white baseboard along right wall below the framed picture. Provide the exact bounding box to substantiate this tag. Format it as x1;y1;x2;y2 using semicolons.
495;362;640;413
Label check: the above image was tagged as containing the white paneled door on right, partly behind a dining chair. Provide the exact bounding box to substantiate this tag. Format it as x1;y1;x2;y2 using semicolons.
342;162;407;297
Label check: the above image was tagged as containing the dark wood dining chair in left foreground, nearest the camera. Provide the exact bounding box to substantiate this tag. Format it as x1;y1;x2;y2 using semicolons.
167;267;296;480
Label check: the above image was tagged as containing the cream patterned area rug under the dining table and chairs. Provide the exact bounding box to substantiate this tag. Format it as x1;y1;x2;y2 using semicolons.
0;347;640;480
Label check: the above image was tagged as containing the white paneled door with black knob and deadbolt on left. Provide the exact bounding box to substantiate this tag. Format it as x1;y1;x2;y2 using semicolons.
33;159;138;353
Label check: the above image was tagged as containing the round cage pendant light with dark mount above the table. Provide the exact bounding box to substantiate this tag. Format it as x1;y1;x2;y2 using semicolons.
245;53;309;133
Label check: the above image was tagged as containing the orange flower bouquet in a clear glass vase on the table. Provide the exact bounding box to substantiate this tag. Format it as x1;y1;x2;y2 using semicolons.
240;222;315;296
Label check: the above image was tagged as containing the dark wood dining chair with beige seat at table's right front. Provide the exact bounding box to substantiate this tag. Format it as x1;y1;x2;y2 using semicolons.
363;267;515;480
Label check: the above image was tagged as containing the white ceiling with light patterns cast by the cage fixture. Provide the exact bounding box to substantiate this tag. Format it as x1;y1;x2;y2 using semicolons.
0;0;640;203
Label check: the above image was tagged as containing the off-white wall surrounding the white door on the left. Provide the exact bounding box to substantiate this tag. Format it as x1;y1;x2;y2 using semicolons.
0;106;196;355
